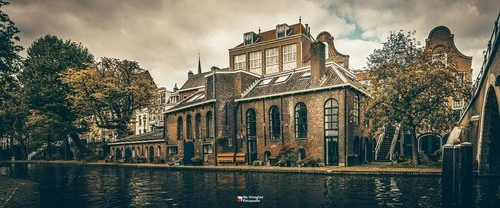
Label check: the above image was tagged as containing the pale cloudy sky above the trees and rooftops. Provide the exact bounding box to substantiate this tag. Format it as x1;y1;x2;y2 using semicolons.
2;0;500;89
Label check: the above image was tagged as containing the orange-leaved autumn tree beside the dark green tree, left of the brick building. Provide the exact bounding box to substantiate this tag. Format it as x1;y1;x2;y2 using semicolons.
62;58;156;138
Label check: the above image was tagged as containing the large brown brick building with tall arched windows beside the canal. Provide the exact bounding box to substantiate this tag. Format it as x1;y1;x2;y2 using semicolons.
165;23;367;166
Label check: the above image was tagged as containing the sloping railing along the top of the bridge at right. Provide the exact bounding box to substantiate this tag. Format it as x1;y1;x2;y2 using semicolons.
460;12;500;118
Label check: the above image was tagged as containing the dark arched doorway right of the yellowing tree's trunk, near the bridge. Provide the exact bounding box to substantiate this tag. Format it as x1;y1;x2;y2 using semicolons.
418;133;443;161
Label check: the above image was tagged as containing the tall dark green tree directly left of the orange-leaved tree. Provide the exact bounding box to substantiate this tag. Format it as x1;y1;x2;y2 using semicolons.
19;35;94;154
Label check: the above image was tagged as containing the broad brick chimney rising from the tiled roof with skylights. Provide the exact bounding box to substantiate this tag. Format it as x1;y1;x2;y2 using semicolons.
311;41;325;87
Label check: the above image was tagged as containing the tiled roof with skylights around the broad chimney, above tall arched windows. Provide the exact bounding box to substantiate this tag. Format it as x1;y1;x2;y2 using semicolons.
242;62;364;99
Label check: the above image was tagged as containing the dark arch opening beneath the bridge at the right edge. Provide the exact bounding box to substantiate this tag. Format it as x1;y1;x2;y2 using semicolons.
481;87;500;174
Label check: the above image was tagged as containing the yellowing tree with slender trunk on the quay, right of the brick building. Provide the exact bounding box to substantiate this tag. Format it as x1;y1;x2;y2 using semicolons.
365;31;465;165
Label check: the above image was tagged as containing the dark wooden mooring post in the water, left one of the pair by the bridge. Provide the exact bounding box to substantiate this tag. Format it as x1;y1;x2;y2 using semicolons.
441;144;454;207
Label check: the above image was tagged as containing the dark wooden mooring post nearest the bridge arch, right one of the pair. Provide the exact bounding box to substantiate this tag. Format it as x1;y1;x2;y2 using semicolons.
460;142;473;207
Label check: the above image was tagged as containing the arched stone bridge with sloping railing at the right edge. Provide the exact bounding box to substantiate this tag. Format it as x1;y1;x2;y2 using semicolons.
458;13;500;175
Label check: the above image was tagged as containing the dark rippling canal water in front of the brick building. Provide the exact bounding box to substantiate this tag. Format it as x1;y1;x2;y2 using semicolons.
0;164;500;208
